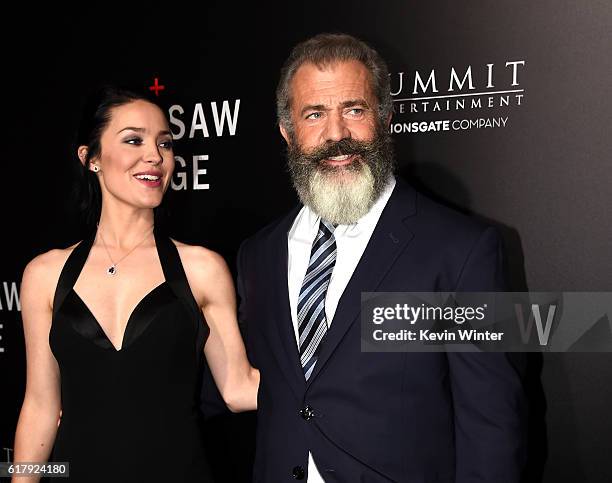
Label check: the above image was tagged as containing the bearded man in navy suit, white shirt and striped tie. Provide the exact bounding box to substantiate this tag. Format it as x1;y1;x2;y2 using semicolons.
238;34;524;483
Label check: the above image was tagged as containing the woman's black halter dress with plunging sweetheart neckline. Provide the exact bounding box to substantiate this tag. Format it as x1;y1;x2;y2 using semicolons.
49;233;212;483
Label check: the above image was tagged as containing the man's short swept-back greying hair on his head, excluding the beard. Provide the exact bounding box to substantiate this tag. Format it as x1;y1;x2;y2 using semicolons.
276;33;393;131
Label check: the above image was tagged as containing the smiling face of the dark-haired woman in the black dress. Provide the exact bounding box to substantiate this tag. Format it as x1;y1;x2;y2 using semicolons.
90;100;174;208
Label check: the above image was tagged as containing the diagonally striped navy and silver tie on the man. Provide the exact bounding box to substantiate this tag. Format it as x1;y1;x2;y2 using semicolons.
297;220;336;380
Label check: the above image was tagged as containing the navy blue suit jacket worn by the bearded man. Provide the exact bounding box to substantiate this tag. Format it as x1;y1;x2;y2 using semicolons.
238;179;525;483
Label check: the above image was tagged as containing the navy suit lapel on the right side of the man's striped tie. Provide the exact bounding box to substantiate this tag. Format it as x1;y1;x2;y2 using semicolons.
308;179;416;386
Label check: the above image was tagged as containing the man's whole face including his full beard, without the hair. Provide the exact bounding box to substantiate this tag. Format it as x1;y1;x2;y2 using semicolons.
281;61;394;225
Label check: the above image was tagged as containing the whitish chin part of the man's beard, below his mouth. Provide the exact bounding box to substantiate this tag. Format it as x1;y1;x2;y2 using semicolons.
294;160;379;225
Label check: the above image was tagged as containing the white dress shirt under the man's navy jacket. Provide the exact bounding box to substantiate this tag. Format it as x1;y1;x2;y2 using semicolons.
287;178;395;483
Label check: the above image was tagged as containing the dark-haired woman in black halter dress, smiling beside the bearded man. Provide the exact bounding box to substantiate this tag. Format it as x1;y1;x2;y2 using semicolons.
14;87;259;483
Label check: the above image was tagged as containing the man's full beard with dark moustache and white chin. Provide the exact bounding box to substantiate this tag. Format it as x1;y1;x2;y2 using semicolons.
287;129;395;225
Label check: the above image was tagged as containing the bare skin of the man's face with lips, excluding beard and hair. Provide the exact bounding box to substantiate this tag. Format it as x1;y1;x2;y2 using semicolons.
281;60;378;163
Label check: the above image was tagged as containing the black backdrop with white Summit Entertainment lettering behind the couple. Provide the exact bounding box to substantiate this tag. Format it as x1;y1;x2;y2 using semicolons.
0;0;612;483
